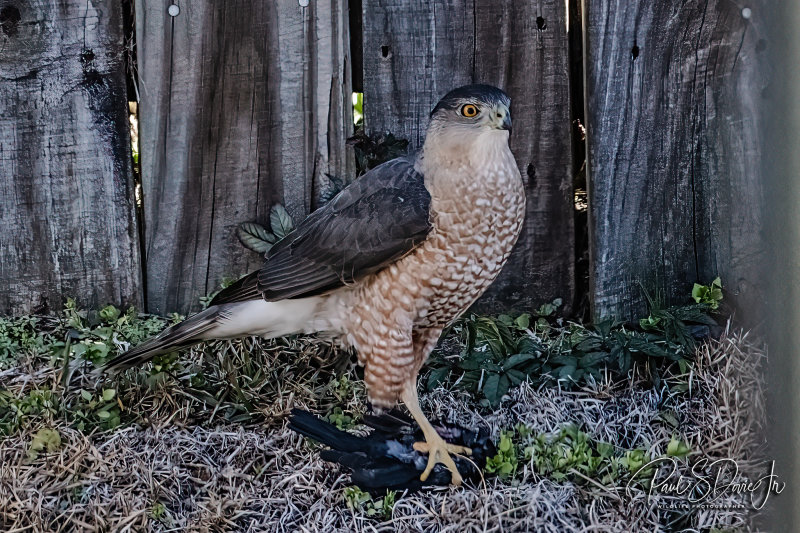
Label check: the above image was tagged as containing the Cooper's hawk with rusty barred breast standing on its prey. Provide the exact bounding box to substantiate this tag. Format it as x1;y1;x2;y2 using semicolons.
107;85;525;485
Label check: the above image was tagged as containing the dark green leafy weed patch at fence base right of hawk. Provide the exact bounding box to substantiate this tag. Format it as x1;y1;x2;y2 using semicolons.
425;281;717;407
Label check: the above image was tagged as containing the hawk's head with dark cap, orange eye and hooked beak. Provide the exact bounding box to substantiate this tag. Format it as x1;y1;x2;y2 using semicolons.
431;84;511;133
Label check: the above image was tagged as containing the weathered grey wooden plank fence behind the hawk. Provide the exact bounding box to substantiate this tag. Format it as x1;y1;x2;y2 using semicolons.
0;0;769;318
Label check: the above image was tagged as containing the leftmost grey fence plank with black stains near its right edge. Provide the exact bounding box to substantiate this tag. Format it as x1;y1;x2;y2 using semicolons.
0;0;141;314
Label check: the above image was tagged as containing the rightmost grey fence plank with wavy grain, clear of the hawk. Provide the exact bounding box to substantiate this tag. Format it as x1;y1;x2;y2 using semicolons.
584;0;765;319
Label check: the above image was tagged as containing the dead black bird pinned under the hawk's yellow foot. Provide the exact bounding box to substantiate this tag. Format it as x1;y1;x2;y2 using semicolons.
289;409;497;495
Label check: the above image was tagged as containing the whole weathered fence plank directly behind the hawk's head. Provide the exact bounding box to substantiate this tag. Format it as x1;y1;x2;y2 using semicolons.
362;0;575;311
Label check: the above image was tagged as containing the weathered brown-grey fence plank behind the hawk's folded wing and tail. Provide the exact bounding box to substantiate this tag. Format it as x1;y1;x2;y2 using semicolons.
137;0;353;313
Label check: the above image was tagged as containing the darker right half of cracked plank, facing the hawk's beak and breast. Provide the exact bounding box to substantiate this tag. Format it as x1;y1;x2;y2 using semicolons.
474;0;575;314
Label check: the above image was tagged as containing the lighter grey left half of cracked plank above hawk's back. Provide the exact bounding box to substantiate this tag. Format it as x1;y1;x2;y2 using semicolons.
362;0;475;148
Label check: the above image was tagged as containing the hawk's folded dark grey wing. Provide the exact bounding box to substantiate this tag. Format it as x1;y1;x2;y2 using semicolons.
211;158;431;305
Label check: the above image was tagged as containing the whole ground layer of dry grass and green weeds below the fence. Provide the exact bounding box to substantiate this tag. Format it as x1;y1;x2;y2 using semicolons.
0;283;764;531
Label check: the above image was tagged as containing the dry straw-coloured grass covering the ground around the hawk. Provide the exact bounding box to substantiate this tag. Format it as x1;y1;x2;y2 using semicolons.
0;322;764;533
